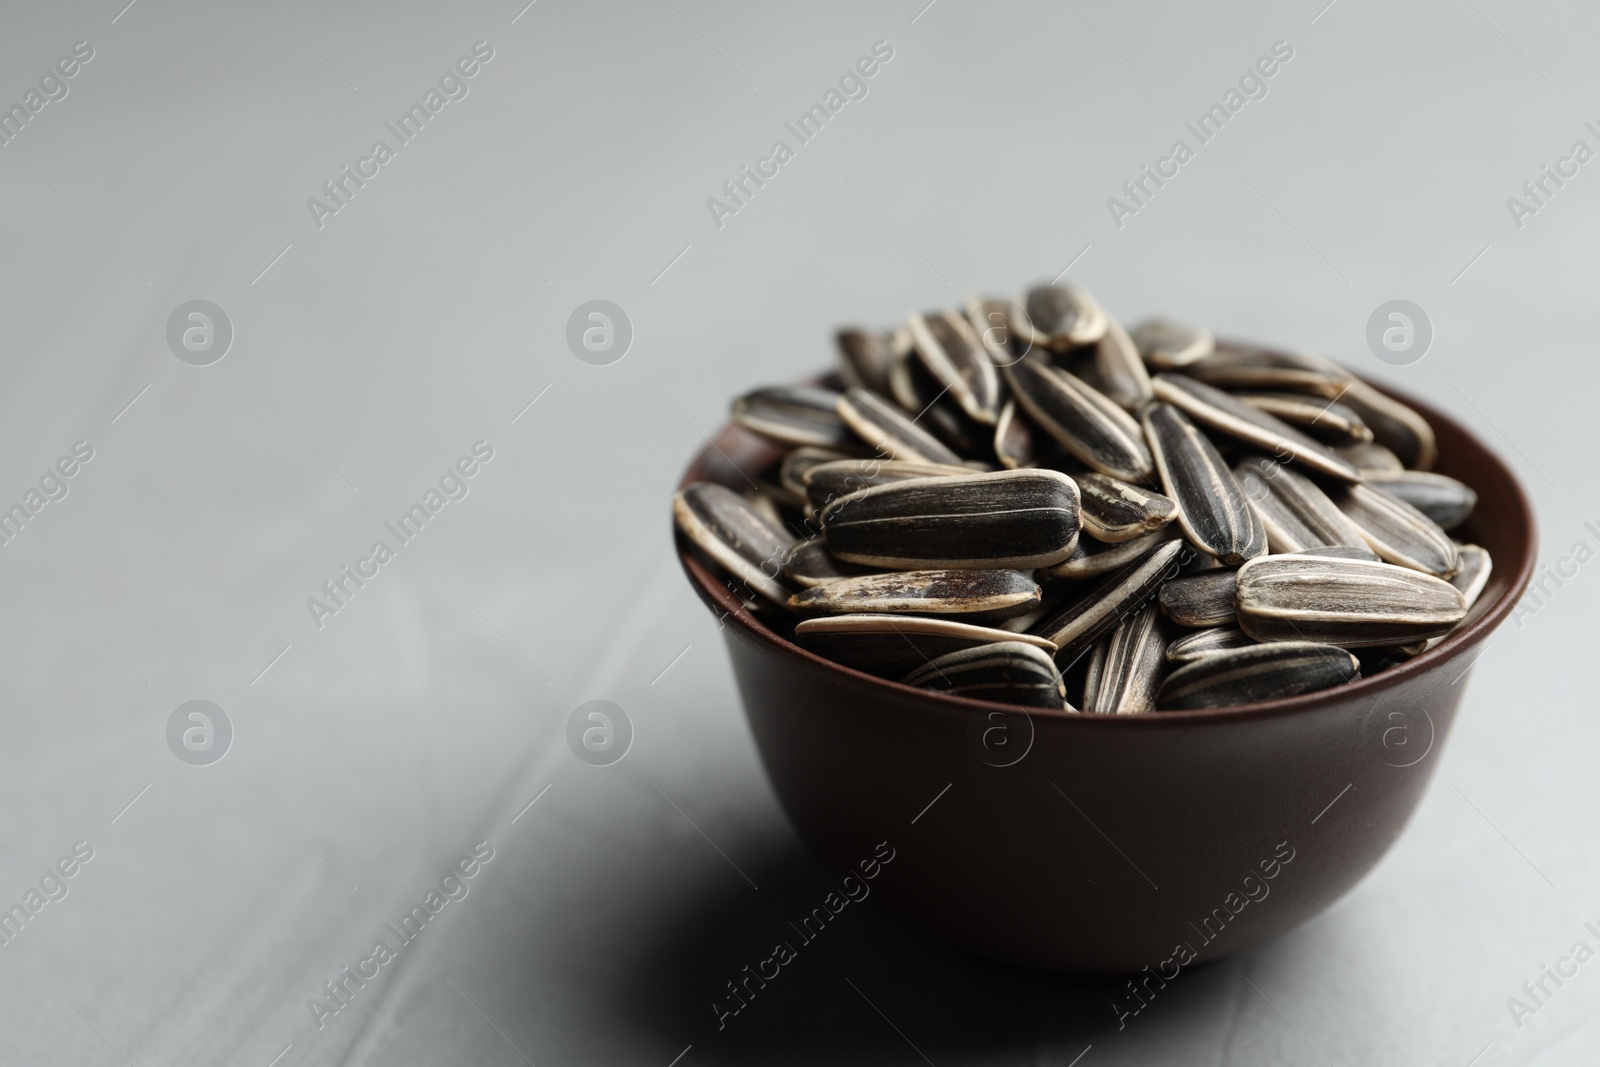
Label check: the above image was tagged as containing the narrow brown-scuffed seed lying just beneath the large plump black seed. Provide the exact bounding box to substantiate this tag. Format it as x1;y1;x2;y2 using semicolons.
789;569;1040;624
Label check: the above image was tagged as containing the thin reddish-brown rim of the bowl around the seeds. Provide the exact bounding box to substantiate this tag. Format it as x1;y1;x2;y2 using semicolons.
674;355;1539;729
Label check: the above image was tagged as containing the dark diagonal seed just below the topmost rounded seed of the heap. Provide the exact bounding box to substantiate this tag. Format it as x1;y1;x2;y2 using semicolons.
1005;357;1154;482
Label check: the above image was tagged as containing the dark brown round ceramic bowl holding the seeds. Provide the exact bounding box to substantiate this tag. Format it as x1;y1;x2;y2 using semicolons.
678;355;1536;977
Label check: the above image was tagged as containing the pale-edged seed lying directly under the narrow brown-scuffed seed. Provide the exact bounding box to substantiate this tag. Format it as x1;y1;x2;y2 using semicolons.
795;614;1056;678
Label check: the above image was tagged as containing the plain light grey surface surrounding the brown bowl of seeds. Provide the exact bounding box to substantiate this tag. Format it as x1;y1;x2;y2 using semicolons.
0;0;1600;1067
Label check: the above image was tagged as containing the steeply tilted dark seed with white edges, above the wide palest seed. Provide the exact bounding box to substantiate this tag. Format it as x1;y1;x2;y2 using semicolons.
1144;403;1267;566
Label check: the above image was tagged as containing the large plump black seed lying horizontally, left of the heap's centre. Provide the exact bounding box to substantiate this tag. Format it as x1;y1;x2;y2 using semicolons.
821;470;1078;569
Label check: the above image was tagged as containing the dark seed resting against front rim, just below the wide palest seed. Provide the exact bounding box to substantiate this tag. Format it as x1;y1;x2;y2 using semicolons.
1157;641;1362;710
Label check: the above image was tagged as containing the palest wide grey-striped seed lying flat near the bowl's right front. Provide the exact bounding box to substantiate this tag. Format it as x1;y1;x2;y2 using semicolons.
1235;555;1467;648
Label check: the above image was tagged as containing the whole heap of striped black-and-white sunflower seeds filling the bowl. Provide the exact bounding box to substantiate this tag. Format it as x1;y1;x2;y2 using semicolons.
674;285;1490;715
